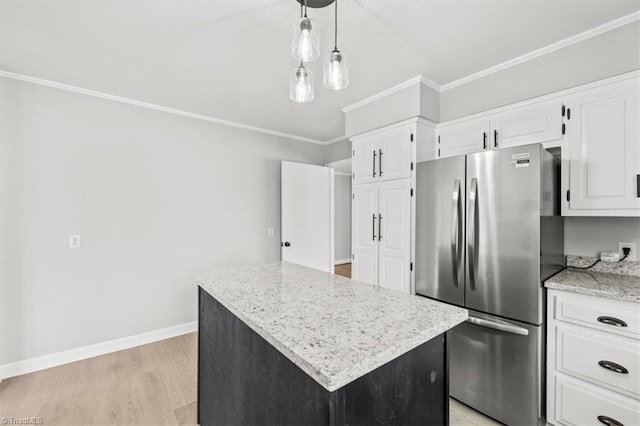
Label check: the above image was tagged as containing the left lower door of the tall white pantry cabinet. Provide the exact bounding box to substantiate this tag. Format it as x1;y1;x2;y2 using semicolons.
351;183;379;284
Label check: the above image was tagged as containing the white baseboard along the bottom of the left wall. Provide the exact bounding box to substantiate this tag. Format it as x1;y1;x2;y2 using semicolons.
0;321;198;380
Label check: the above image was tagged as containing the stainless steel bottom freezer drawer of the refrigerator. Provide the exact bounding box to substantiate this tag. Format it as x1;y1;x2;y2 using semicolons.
448;311;544;425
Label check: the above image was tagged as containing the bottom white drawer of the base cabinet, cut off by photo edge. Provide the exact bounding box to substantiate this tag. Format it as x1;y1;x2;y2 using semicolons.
548;375;640;426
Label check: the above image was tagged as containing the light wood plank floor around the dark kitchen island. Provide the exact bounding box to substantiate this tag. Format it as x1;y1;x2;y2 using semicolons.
0;333;498;426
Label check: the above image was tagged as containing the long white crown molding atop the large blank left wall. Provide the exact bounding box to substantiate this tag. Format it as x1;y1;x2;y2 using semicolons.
0;70;336;145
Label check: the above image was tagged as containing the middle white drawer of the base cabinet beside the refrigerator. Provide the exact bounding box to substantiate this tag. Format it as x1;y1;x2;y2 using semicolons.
555;325;640;398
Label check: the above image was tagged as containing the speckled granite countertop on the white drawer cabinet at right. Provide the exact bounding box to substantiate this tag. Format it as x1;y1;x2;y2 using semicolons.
544;268;640;303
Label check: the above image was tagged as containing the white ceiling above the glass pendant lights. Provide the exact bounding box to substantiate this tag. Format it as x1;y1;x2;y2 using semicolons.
0;0;640;141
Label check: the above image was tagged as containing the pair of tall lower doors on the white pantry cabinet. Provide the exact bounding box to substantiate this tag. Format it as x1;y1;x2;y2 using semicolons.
351;179;411;293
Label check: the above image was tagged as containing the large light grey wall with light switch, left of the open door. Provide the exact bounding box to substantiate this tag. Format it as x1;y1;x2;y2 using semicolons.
0;78;325;364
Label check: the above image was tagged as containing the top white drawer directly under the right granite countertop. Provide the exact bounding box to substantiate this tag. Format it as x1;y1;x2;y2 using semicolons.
549;292;640;339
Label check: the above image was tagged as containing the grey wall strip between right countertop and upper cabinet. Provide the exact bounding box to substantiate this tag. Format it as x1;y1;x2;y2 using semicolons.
564;217;640;260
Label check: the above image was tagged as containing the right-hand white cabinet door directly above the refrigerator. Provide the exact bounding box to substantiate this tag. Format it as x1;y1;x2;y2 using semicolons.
490;101;562;148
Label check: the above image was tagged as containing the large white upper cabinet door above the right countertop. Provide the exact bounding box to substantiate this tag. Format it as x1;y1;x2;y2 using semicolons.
566;79;640;212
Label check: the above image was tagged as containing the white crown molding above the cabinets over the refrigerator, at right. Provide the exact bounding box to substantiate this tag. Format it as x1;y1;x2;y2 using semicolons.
440;11;640;93
